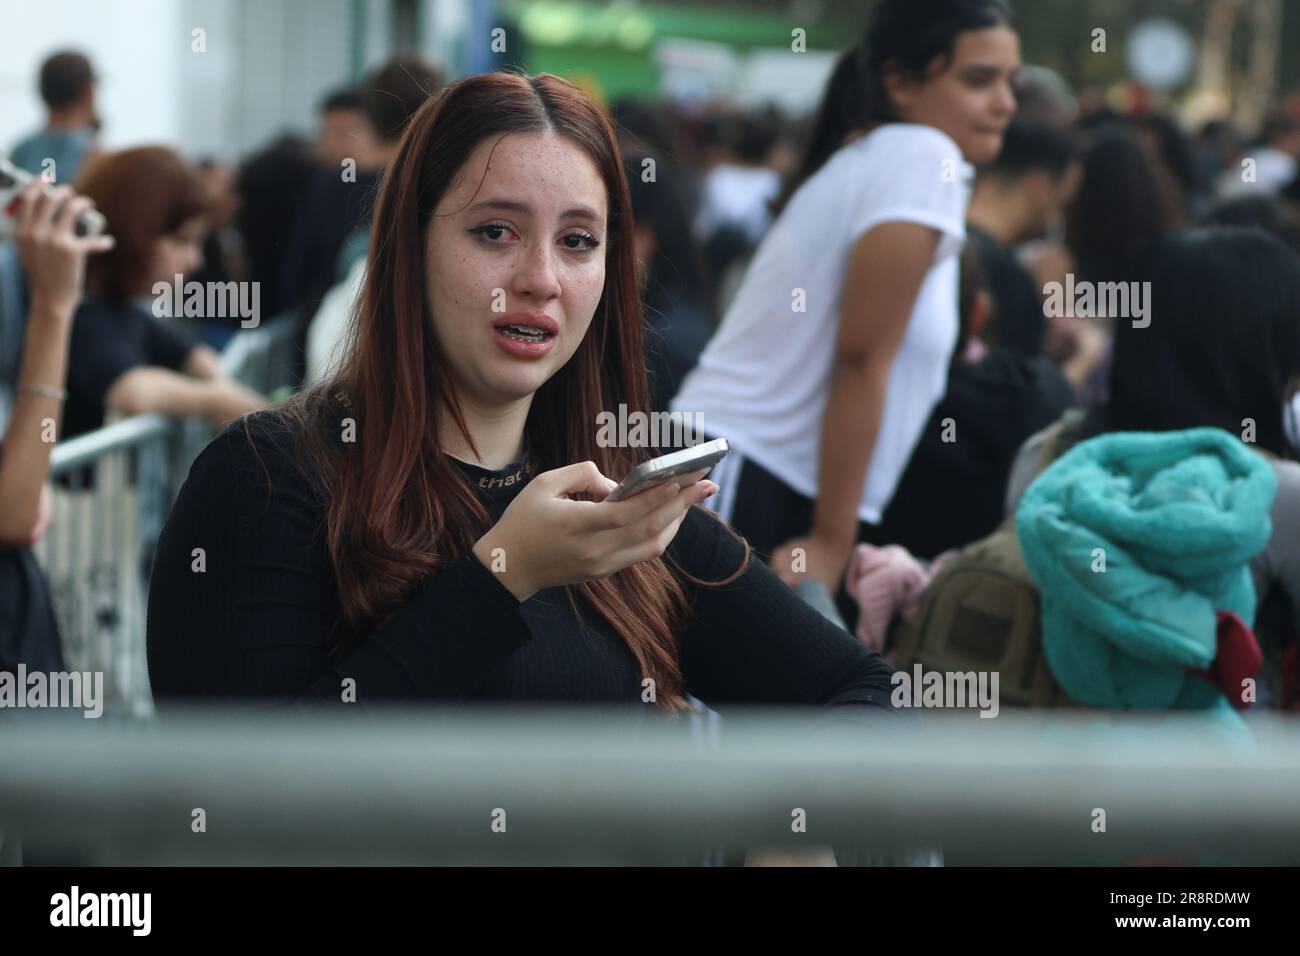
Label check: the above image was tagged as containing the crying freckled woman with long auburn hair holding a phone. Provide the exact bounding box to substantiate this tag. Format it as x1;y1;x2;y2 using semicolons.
148;73;893;714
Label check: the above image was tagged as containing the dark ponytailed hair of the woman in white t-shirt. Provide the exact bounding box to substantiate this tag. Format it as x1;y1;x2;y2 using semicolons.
776;0;1011;209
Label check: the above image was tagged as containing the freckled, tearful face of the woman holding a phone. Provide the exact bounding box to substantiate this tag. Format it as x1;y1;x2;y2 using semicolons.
425;133;608;407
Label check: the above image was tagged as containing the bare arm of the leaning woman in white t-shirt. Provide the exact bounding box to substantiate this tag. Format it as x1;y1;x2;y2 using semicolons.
774;222;940;591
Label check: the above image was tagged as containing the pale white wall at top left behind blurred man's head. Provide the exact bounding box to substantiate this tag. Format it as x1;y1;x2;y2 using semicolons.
0;0;361;160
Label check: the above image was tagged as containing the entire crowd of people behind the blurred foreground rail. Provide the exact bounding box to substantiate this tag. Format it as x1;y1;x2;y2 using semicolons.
0;0;1300;738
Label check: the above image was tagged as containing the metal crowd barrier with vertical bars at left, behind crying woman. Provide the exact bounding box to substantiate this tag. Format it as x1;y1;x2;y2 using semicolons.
34;316;294;717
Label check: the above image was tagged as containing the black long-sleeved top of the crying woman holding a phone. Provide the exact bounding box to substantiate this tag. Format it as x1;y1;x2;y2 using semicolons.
148;412;893;719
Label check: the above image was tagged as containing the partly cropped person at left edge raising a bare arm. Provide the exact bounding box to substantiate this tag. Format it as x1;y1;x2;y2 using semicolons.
0;179;113;672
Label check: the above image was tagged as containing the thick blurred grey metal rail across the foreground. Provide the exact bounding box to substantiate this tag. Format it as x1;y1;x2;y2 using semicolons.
0;708;1300;865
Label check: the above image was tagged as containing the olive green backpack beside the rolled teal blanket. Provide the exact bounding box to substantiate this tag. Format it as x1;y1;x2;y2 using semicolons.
893;410;1083;708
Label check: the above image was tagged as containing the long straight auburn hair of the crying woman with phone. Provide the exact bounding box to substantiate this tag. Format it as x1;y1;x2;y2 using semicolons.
269;72;750;710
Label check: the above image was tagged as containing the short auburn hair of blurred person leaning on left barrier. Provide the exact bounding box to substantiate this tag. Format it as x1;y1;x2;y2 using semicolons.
77;146;213;304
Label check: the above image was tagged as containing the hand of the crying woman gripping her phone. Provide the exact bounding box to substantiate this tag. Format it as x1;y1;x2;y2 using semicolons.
473;462;718;602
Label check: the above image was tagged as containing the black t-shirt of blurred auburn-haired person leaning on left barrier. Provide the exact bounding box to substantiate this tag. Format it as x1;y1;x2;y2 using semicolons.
62;295;199;438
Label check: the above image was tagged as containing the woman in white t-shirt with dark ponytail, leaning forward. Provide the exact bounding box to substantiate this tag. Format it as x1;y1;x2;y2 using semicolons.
672;0;1021;591
